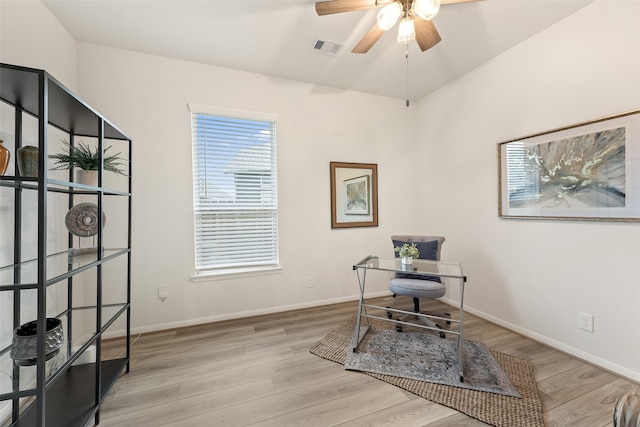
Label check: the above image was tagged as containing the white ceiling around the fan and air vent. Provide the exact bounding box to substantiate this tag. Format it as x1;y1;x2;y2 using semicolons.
43;0;593;100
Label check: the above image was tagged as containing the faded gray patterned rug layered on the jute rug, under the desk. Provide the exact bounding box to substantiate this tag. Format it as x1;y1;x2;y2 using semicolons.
344;329;521;398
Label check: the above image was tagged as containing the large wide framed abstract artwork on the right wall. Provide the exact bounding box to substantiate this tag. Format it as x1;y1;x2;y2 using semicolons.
498;110;640;221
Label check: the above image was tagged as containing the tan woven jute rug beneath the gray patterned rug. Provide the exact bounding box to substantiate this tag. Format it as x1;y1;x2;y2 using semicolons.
309;317;544;427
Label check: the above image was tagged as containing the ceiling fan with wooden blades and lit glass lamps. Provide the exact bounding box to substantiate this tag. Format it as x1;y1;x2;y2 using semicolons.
316;0;478;53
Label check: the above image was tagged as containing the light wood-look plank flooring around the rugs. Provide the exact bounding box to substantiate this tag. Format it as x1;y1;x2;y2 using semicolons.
100;297;640;427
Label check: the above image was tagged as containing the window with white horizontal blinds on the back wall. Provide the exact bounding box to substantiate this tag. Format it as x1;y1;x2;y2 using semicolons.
189;104;278;274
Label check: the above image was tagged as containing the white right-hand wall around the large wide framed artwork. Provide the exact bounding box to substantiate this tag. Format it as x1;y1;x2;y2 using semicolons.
418;1;640;380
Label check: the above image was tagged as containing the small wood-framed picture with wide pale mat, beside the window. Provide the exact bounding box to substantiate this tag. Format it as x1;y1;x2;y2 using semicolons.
329;162;378;228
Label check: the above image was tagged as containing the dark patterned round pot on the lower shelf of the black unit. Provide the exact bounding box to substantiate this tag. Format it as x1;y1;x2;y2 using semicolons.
9;317;64;366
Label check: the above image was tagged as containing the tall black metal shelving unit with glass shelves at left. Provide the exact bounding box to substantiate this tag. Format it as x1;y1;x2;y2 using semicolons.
0;64;132;427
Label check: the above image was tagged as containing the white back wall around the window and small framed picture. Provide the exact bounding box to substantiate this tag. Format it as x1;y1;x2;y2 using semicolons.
78;43;417;330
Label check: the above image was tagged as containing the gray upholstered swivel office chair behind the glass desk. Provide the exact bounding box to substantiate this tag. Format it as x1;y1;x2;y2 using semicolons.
387;235;446;338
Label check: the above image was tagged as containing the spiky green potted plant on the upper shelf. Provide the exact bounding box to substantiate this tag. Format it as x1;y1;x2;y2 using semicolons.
49;140;125;185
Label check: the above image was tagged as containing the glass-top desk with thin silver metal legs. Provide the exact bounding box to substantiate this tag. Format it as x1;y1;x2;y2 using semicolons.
351;255;467;382
